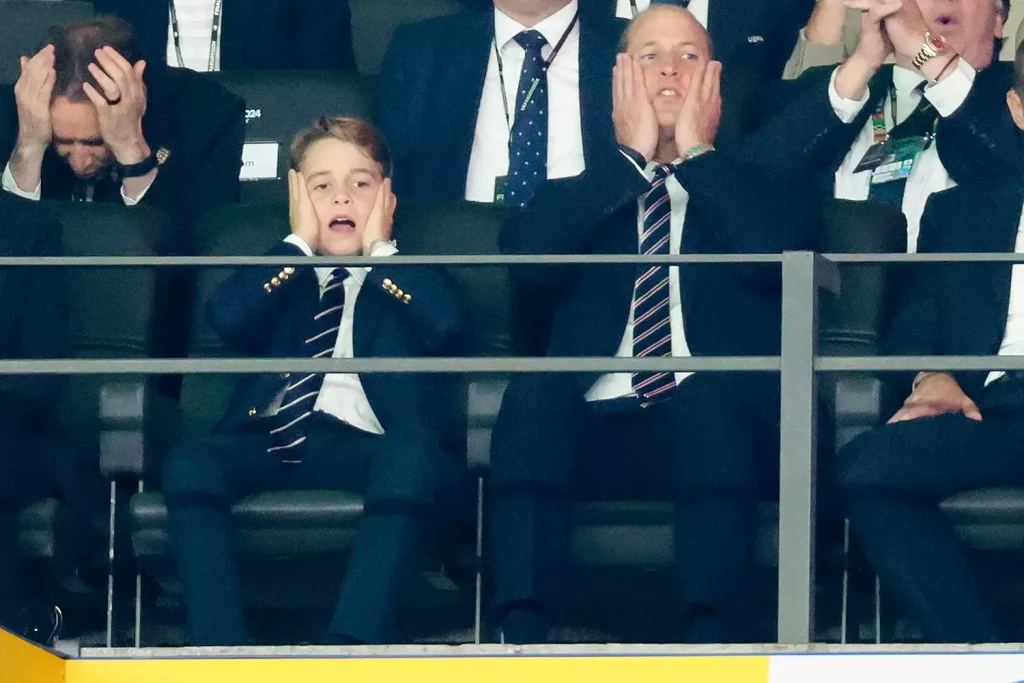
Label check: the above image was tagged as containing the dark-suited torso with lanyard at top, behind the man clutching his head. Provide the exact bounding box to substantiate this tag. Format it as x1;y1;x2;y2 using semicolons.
93;0;355;72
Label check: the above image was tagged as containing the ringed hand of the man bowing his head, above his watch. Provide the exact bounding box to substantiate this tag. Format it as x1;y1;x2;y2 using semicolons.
83;47;150;165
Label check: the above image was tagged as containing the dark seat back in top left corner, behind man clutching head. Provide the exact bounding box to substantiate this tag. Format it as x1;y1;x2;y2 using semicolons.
0;0;93;83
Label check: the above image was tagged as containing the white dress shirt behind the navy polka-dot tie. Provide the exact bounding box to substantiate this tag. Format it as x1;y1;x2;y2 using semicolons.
466;0;585;202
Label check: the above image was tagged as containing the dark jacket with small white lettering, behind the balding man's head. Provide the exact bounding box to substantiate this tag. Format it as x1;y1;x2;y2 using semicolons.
581;0;814;79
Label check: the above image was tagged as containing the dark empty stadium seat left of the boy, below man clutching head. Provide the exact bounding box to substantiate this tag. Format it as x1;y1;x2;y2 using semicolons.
19;198;170;647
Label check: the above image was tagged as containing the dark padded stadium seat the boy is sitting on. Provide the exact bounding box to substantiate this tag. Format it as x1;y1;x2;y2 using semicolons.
132;198;507;638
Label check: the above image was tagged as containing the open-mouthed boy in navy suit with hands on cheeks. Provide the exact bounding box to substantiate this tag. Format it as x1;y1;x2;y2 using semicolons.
163;117;465;645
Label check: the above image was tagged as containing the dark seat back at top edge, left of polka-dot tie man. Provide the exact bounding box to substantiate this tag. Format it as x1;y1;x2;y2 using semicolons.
348;0;463;75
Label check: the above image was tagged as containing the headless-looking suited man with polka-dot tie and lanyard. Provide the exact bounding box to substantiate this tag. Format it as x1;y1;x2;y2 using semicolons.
380;0;617;206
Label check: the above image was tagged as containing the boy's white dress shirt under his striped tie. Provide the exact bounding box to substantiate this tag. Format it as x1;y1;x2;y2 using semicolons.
285;234;398;434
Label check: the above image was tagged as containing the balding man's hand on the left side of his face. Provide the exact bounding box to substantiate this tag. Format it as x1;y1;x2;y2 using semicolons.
611;53;658;161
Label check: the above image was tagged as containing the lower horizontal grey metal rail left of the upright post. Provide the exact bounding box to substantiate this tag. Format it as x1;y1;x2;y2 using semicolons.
0;356;780;376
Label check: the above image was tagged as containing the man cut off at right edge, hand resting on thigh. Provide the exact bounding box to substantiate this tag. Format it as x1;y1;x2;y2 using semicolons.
839;41;1024;643
